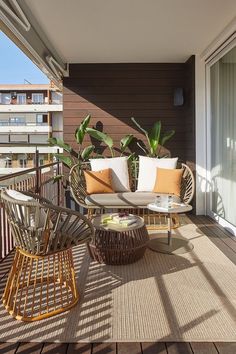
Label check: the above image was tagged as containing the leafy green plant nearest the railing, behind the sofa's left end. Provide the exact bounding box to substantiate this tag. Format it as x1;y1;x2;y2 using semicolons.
48;115;95;173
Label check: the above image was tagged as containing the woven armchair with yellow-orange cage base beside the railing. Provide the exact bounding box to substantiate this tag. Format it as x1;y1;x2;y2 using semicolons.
0;190;94;321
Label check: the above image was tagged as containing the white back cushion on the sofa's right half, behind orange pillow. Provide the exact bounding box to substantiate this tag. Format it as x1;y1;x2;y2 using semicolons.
136;156;178;192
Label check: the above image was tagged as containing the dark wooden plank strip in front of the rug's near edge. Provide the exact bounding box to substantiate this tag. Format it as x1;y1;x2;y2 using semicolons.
0;342;236;354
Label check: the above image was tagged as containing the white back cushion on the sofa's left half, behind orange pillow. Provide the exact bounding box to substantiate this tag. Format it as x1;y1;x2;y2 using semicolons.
90;157;130;192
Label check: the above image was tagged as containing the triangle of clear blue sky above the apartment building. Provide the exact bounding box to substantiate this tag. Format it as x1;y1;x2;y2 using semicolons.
0;31;49;84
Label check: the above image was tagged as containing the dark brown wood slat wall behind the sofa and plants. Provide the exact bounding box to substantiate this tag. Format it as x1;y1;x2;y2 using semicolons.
63;57;195;166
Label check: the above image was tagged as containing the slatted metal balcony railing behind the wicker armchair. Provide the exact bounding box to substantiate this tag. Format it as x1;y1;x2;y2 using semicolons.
0;153;64;261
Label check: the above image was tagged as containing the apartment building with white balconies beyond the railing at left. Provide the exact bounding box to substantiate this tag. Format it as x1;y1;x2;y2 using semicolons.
0;83;63;173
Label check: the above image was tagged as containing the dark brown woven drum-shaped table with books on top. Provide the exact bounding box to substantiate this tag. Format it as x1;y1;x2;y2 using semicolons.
88;214;149;265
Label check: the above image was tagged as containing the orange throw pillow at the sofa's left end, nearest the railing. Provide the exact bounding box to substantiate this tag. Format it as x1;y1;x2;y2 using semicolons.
84;168;114;194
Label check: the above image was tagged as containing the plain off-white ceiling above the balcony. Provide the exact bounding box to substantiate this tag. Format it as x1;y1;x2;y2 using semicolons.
19;0;236;63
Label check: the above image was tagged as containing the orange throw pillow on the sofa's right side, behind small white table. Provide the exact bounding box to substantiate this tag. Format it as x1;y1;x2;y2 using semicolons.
153;168;183;197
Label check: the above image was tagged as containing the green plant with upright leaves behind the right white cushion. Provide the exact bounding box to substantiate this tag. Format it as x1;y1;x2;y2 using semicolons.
131;117;175;157
